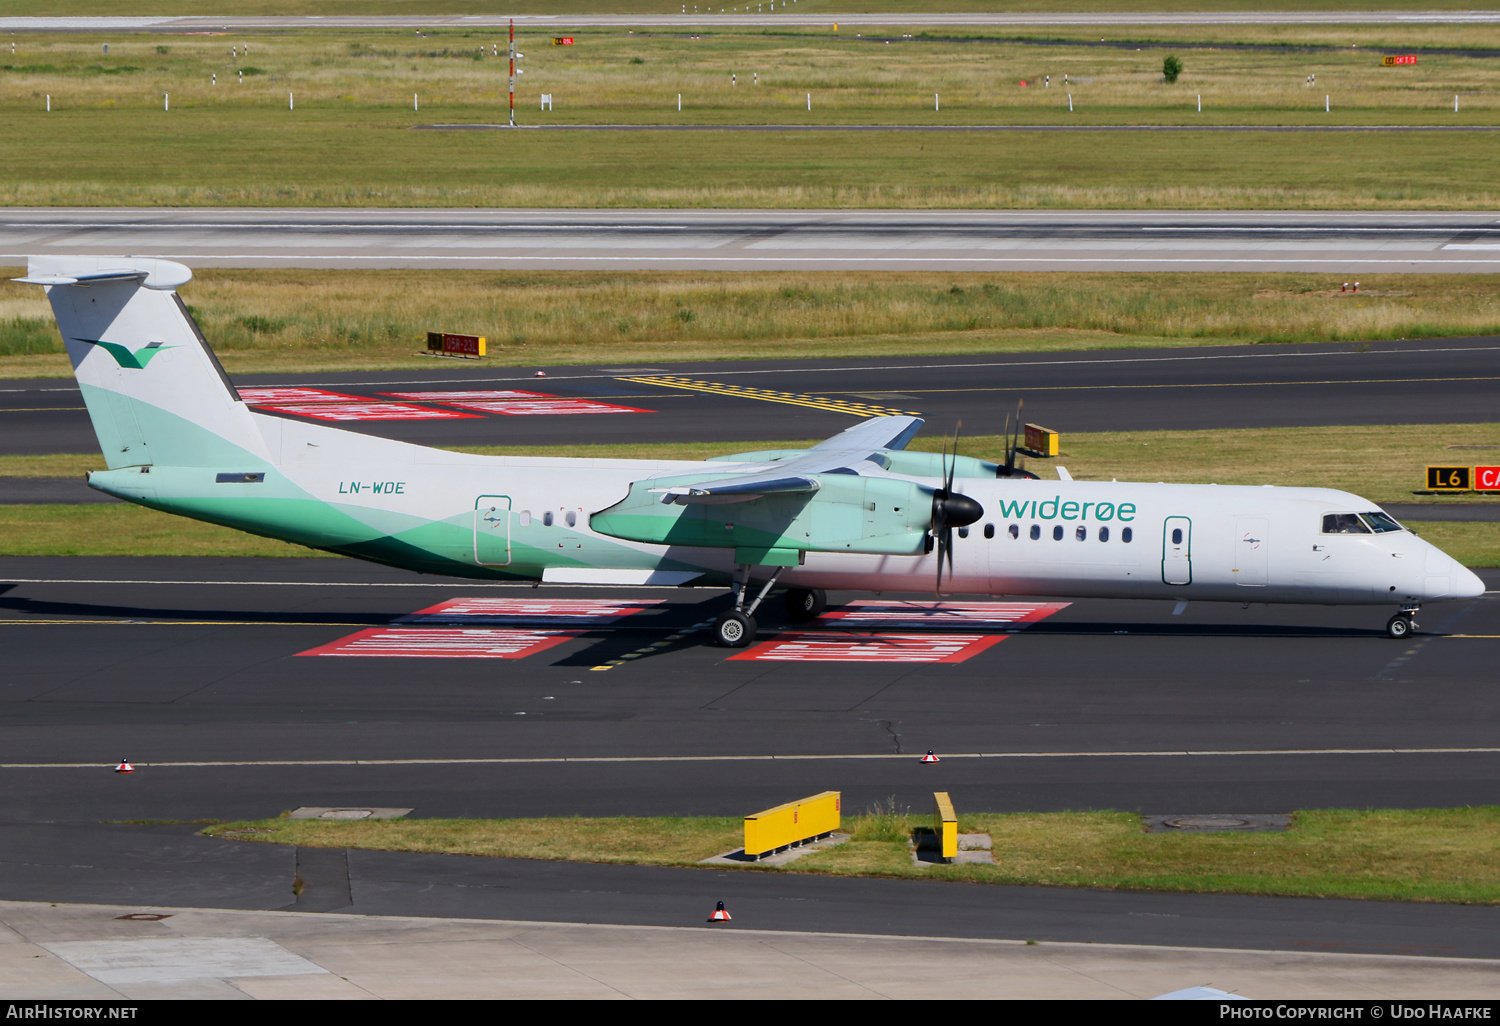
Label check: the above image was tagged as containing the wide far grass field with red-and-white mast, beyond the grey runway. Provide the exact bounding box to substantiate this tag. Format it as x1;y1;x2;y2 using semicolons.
0;26;1500;209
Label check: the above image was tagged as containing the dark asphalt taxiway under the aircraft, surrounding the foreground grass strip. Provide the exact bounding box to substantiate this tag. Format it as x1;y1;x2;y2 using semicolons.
0;558;1500;957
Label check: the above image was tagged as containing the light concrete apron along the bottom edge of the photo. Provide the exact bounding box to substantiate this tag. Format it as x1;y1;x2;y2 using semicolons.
0;902;1500;1001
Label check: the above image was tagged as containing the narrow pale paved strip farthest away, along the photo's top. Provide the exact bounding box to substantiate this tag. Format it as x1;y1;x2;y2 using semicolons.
11;8;1500;33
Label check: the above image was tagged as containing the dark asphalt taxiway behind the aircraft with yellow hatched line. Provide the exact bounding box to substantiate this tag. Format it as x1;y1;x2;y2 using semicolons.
0;336;1500;462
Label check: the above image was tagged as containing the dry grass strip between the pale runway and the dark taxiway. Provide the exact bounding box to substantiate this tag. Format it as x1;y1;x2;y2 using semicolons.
0;268;1500;378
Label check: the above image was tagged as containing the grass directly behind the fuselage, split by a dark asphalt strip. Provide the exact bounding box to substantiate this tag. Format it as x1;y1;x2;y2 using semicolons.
0;425;1500;567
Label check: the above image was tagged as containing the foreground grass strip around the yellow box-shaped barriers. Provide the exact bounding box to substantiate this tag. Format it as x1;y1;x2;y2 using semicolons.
203;795;1500;905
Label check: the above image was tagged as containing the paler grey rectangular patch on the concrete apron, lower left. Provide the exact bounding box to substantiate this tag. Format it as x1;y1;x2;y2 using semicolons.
39;938;327;986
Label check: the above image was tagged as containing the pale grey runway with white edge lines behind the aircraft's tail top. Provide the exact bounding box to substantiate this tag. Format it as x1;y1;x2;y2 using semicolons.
0;209;1500;270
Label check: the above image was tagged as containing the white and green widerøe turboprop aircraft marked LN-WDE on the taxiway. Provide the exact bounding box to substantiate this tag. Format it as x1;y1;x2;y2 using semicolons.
18;257;1485;647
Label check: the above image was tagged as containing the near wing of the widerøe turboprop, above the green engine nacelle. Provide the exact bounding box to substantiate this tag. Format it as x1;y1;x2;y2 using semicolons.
651;417;923;503
